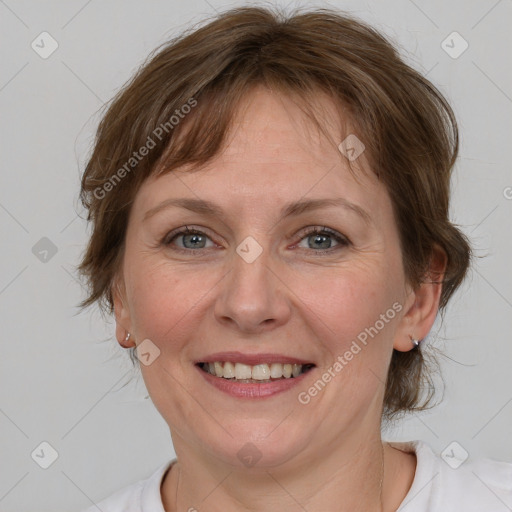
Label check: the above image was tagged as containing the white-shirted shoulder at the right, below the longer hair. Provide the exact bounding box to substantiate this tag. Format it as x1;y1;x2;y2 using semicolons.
390;441;512;512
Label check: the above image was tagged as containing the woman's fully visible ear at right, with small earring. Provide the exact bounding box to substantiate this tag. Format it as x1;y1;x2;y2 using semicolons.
393;245;448;352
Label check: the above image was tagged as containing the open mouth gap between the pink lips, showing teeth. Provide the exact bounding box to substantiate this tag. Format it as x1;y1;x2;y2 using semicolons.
196;361;315;384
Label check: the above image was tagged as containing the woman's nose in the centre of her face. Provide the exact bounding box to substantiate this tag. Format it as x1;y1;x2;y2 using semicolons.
215;242;291;333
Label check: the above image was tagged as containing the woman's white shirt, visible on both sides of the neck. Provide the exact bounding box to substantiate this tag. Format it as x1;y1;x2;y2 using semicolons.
83;441;512;512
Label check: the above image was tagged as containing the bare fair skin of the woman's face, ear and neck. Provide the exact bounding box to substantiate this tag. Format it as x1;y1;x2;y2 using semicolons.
114;87;446;512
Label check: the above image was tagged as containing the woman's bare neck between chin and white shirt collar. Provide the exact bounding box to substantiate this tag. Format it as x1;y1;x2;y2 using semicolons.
162;433;395;512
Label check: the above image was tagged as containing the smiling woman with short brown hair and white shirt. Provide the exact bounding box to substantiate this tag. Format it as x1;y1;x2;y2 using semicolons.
80;8;512;512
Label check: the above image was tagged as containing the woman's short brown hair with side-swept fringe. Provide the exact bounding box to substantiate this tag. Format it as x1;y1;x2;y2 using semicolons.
79;7;471;417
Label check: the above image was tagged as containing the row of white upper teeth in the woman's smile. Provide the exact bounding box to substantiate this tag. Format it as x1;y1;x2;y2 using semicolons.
204;361;308;380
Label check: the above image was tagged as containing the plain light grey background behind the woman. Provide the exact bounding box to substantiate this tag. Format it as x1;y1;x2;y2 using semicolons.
0;0;512;512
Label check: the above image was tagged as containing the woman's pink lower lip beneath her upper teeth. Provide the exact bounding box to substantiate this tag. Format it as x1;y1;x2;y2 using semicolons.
196;366;313;398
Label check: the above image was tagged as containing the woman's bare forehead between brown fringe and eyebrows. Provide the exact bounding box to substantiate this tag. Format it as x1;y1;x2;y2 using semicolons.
133;87;385;222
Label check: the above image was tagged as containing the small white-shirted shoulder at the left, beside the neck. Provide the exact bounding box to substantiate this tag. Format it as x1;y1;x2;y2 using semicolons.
82;460;175;512
